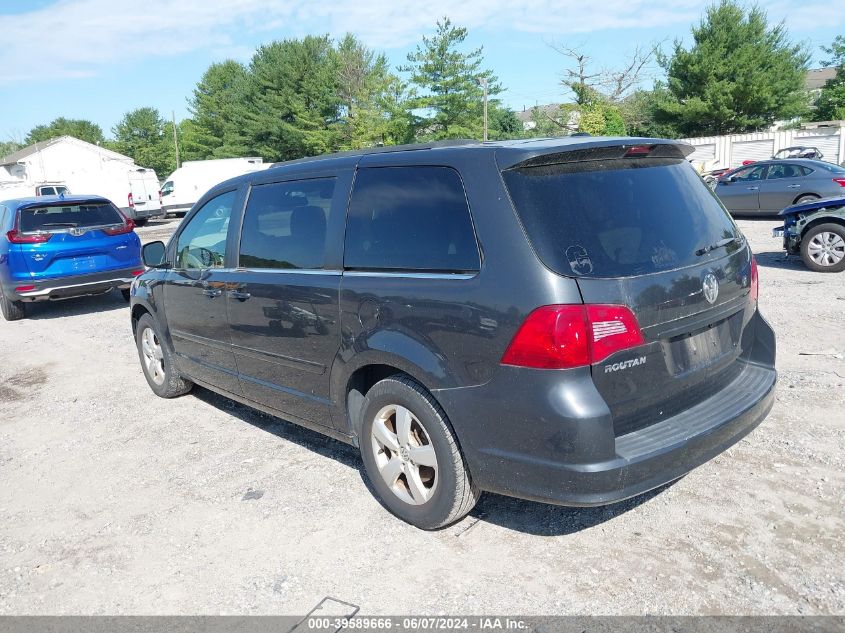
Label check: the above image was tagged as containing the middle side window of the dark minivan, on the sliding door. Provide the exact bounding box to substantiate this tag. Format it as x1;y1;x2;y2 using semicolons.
238;178;335;270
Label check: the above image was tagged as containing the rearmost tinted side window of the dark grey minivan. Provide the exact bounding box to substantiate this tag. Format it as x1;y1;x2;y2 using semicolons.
343;166;474;272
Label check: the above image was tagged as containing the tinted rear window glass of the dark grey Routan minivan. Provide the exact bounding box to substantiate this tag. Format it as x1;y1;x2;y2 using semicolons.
503;158;742;277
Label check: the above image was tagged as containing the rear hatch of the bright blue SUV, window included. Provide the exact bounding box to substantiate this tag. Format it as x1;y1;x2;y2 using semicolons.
15;200;140;279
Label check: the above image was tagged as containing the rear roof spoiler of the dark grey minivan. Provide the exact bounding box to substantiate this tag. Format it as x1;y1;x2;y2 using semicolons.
506;139;695;170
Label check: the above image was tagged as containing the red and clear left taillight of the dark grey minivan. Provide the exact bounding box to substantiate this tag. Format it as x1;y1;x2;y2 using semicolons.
501;305;645;369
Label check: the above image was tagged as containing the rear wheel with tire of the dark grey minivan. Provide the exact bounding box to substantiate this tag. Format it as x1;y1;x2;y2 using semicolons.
359;375;480;530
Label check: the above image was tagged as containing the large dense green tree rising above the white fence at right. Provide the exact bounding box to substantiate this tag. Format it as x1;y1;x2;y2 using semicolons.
661;0;809;136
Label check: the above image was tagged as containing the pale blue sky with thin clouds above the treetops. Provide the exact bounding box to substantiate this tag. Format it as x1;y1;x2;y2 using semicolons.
0;0;845;141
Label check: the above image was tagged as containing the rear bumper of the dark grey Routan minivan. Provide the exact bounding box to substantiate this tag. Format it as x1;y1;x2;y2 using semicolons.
435;308;777;506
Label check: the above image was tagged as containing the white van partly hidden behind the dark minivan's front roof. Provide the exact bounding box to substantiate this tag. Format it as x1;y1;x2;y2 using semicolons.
161;157;270;213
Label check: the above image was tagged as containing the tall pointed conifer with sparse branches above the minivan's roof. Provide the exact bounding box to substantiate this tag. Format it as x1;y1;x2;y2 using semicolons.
399;18;502;140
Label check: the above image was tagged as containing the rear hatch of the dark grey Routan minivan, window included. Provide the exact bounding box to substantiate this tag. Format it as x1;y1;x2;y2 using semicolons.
503;144;756;435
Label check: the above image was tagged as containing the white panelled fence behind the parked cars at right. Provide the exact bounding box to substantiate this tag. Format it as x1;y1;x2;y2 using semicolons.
681;121;845;170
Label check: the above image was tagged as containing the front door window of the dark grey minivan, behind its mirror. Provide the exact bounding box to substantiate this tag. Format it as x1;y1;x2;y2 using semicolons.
176;191;237;269
